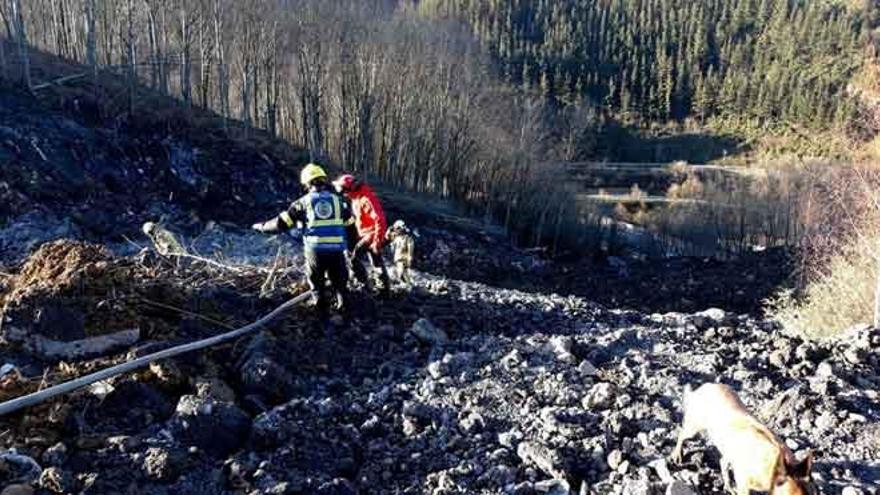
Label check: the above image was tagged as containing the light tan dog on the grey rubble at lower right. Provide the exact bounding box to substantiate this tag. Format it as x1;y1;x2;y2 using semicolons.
672;383;813;495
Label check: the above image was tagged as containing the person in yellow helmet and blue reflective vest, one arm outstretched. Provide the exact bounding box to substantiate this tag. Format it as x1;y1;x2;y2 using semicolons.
253;163;352;327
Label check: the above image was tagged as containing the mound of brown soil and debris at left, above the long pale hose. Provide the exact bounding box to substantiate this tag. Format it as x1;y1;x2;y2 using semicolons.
0;240;298;355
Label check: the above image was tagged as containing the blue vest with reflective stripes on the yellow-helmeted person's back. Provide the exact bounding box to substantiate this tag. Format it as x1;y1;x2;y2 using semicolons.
303;191;346;252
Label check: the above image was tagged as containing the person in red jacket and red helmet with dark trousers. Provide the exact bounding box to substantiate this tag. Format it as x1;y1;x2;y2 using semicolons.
333;174;391;294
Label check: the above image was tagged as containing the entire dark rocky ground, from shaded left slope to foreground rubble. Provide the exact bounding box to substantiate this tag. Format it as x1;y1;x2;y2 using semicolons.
0;62;880;495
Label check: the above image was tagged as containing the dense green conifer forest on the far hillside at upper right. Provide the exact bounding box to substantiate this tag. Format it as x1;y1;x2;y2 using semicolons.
419;0;877;128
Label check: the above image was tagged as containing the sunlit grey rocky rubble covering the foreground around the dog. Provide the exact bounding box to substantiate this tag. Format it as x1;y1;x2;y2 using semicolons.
0;246;880;494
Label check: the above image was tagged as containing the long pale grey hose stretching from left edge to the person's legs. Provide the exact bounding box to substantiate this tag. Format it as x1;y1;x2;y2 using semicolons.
0;291;311;416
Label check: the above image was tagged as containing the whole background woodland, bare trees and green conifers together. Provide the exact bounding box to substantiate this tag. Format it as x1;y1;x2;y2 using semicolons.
0;0;877;252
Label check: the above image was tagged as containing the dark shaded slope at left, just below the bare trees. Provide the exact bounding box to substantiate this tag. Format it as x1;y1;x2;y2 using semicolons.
0;88;307;263
